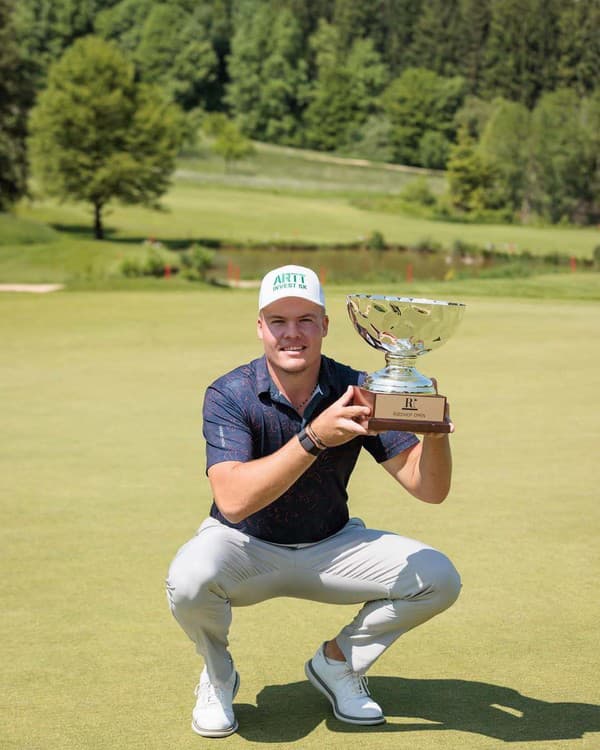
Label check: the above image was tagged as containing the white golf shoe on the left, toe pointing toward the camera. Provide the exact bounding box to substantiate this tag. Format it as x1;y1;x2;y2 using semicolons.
192;667;240;737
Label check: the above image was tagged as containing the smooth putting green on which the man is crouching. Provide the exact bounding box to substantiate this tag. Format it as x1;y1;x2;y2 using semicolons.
0;287;600;750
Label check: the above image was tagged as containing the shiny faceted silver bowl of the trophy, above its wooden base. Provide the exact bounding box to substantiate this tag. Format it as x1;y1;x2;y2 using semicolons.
346;294;465;395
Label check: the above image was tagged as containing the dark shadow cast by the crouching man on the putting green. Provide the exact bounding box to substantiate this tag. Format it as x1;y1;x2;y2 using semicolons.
235;677;600;742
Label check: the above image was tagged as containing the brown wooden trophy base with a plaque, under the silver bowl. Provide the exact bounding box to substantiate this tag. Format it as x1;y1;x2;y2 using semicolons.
354;386;450;433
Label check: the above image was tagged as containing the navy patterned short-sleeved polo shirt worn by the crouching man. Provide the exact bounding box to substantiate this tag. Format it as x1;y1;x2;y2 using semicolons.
203;356;418;545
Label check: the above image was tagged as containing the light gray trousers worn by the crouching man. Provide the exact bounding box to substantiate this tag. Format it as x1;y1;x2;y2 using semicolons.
167;518;460;685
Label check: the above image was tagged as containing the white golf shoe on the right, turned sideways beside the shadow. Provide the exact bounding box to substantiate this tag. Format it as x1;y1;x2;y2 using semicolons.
304;644;385;724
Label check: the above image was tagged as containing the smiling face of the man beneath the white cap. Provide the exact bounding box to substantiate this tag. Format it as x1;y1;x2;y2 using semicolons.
257;297;329;373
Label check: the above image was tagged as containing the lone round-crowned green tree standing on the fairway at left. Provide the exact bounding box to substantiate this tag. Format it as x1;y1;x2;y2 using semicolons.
29;37;184;239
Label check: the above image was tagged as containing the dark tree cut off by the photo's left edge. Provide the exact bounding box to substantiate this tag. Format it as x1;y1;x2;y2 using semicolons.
0;0;33;211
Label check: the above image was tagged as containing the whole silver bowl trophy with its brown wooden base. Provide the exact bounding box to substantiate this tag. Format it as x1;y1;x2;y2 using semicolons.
346;294;465;432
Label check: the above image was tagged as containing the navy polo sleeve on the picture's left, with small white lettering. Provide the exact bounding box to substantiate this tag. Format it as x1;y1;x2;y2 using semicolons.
202;385;253;471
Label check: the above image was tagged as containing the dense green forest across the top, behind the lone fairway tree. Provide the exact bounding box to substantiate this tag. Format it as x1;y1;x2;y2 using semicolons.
0;0;600;223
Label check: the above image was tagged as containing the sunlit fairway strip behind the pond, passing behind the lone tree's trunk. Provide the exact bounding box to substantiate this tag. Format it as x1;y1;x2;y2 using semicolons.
19;180;599;258
